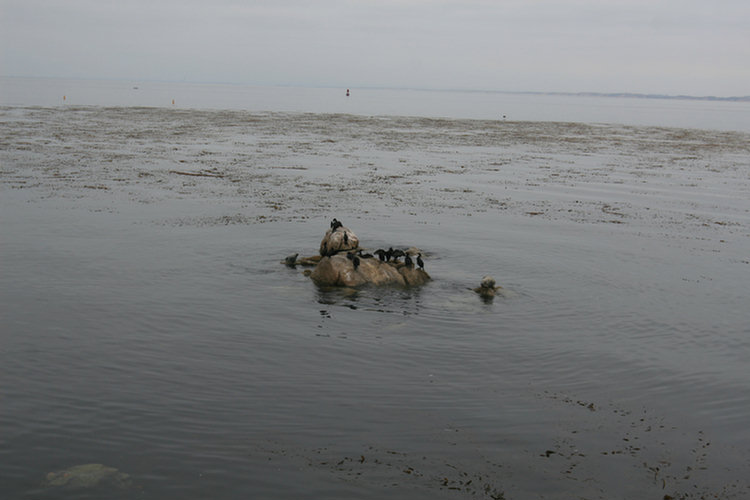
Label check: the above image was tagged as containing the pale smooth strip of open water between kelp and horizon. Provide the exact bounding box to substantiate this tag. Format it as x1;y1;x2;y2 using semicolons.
0;78;750;132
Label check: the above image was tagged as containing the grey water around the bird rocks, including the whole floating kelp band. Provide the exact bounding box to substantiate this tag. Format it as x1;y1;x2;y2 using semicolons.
0;107;750;499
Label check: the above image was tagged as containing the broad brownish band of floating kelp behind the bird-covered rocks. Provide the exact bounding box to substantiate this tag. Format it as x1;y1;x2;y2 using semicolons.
2;108;750;238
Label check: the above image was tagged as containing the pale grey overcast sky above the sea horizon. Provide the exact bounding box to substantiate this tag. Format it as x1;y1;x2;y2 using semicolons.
0;0;750;97
